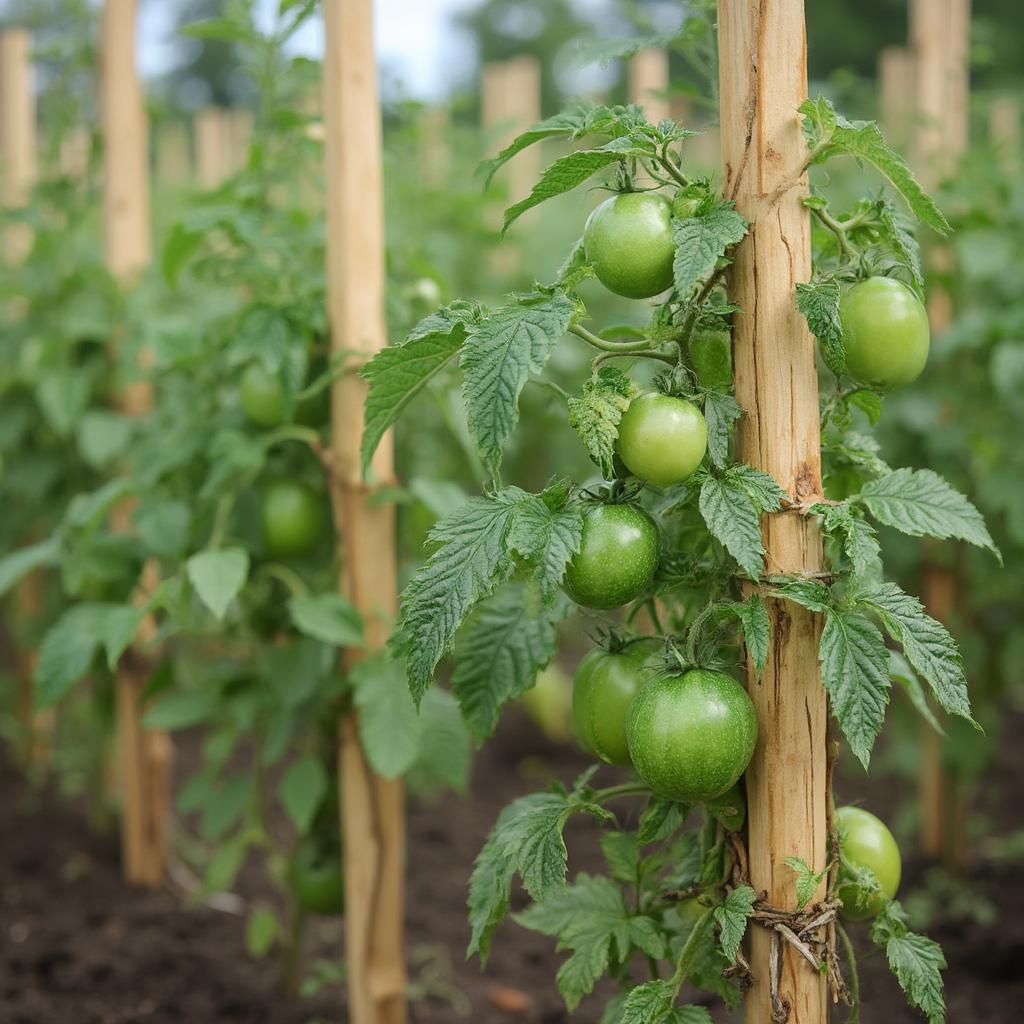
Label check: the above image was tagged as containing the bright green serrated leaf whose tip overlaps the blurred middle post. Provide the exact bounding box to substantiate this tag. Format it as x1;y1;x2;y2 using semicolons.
359;310;468;474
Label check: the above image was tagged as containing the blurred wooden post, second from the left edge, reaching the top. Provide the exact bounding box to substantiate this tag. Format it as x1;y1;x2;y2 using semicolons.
100;0;171;888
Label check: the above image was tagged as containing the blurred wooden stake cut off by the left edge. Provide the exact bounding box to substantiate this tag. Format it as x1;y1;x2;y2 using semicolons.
0;29;36;263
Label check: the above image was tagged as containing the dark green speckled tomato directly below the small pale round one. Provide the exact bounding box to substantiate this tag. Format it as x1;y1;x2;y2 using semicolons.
564;505;660;609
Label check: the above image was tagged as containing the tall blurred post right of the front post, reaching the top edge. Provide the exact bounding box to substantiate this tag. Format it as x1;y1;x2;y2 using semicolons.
909;0;971;858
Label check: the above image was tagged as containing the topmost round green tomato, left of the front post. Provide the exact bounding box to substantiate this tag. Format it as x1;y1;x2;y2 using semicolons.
583;193;676;299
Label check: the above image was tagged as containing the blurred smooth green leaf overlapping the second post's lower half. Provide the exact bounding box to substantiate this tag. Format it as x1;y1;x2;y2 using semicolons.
349;654;422;778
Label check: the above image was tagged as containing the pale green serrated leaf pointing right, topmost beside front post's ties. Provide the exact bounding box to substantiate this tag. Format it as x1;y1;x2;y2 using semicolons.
860;469;1002;563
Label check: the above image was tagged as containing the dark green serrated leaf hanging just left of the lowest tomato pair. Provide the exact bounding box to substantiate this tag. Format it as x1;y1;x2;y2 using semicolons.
452;585;568;742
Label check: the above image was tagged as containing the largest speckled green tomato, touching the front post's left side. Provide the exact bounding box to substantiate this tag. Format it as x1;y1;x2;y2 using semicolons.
626;669;758;801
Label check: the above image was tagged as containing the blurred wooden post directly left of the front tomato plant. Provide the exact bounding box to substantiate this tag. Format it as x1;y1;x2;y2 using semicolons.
324;0;407;1024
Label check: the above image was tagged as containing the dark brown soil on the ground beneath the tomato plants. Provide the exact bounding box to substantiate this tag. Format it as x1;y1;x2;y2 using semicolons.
0;712;1024;1024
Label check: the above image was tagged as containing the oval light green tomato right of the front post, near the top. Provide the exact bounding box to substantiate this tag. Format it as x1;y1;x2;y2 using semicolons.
839;278;929;388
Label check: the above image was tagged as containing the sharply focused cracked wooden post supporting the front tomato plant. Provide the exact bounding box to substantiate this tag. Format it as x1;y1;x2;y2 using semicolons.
718;0;827;1024
